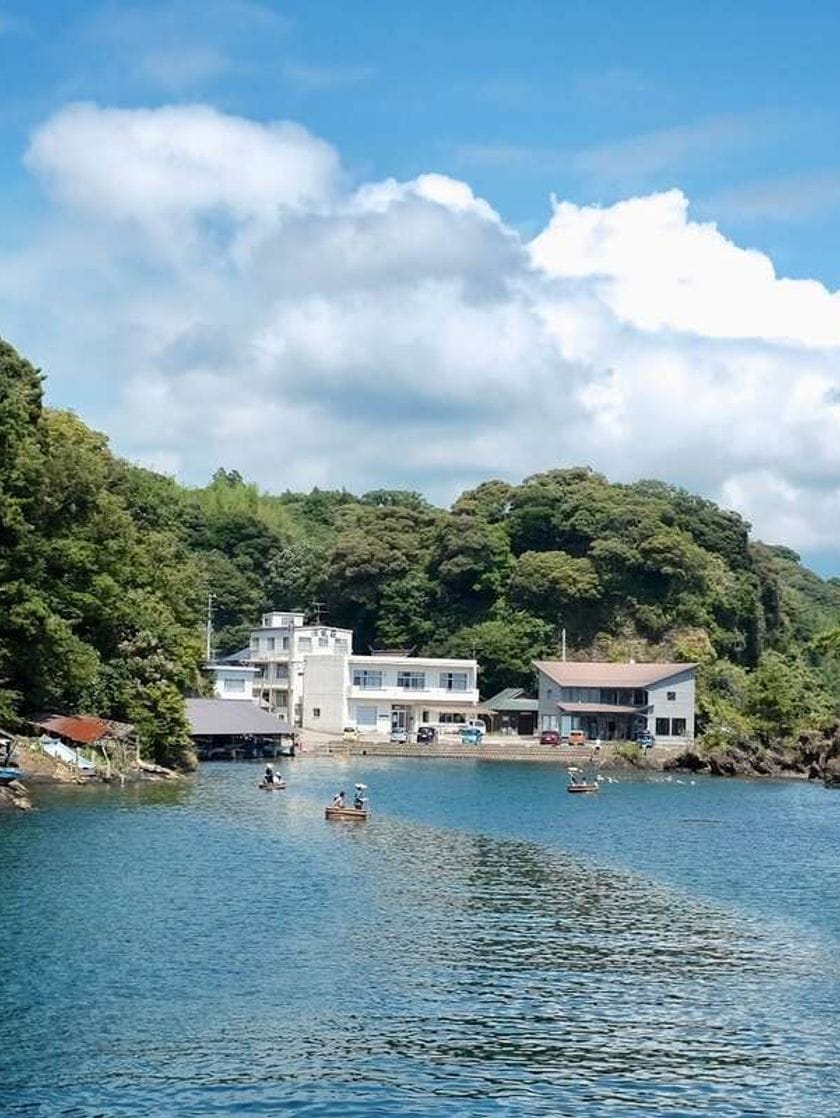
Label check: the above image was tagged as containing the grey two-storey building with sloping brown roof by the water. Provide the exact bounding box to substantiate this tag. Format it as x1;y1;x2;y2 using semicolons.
534;660;697;745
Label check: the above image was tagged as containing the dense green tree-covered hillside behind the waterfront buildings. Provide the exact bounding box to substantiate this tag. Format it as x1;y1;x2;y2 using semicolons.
0;343;840;760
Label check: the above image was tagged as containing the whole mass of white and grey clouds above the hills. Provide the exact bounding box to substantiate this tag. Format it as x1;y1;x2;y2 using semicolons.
0;105;840;552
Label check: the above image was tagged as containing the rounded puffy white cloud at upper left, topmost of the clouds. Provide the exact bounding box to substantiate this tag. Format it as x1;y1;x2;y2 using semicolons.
26;104;338;226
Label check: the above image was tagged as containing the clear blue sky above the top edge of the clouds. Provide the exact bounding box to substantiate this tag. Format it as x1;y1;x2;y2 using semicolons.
6;0;840;287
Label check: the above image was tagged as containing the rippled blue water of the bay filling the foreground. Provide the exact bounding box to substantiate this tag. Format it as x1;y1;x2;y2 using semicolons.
0;758;840;1118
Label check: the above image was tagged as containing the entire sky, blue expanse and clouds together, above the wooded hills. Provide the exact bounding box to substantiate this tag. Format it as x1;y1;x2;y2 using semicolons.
0;0;840;575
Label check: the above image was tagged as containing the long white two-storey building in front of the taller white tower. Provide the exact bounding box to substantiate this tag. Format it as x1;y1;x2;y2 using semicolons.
303;653;479;737
